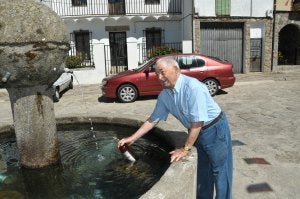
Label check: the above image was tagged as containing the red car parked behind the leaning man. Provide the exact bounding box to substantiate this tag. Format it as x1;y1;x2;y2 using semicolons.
101;54;235;102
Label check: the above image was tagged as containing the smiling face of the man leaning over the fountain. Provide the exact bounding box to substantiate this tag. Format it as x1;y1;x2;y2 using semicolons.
155;62;179;89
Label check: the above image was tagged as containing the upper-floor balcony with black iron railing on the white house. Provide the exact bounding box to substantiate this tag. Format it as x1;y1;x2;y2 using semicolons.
41;0;182;16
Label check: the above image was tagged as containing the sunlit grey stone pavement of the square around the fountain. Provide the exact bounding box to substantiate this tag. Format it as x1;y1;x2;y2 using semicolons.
0;70;300;199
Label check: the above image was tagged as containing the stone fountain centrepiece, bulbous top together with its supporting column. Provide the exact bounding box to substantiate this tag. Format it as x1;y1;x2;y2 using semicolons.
0;0;69;168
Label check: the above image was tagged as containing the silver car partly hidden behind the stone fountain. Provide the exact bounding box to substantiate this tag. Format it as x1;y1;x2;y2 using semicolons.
53;68;73;102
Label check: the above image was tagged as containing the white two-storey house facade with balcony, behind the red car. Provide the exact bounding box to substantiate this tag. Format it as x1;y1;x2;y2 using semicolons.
41;0;193;84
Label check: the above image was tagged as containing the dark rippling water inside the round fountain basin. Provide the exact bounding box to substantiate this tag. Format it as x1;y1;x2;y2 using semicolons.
0;122;170;199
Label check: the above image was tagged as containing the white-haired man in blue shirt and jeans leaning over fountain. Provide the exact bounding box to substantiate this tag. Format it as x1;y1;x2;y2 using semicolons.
118;58;232;199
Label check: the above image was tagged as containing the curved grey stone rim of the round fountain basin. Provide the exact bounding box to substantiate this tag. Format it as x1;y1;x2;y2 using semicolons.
0;117;197;199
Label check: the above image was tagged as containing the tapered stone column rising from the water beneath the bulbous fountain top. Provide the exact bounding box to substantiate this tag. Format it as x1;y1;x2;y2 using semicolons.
7;86;60;168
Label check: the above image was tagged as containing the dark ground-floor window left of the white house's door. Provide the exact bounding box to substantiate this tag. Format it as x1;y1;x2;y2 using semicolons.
74;30;91;60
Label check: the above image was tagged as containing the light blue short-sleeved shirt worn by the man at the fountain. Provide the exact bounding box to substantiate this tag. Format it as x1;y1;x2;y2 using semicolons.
150;74;221;128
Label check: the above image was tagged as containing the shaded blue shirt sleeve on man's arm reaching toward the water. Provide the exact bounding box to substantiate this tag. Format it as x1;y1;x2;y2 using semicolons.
150;94;169;122
